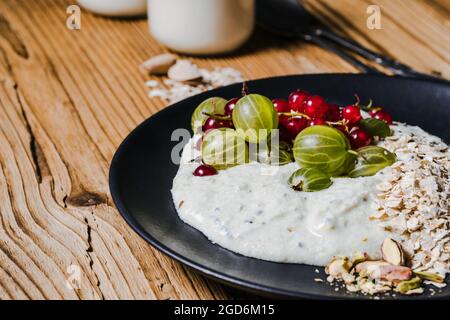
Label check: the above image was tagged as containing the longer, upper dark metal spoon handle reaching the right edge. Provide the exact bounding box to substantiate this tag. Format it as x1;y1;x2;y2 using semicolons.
314;28;445;81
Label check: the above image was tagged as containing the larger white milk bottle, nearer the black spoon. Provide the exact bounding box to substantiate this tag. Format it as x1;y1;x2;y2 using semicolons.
147;0;255;54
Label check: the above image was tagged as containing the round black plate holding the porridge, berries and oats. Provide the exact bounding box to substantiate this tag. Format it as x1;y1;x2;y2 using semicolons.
110;74;450;299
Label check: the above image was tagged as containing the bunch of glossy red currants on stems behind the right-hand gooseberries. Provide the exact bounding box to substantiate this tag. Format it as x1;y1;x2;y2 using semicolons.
272;90;392;149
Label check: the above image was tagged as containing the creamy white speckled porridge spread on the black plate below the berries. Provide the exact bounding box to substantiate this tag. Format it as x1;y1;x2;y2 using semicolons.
172;124;440;266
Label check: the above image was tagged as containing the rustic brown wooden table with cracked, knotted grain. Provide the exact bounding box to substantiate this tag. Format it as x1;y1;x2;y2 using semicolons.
0;0;450;299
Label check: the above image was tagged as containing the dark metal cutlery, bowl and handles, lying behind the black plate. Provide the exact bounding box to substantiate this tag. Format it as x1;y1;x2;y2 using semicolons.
256;0;445;81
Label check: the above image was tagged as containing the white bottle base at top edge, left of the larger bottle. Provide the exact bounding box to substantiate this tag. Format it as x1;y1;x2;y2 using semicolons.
78;0;147;17
